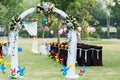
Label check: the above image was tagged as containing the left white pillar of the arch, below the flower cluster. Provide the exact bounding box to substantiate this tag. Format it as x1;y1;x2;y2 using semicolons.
10;31;18;77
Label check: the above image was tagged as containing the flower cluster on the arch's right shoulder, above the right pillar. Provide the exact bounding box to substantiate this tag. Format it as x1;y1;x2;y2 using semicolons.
66;16;79;30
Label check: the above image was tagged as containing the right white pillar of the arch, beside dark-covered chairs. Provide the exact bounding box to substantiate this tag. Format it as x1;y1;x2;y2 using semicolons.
66;30;79;79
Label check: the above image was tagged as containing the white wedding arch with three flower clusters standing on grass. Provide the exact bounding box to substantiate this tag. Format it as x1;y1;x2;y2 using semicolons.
10;2;78;78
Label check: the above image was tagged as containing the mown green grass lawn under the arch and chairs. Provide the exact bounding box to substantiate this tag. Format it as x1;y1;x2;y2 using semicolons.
0;38;120;80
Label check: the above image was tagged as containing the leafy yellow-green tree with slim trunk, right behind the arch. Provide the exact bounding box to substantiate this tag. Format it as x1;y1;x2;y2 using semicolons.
67;0;98;39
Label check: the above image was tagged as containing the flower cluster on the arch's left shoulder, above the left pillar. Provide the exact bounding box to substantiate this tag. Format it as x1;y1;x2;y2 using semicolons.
10;14;23;31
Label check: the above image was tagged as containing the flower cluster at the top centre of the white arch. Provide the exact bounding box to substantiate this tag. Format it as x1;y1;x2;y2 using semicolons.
36;2;54;14
